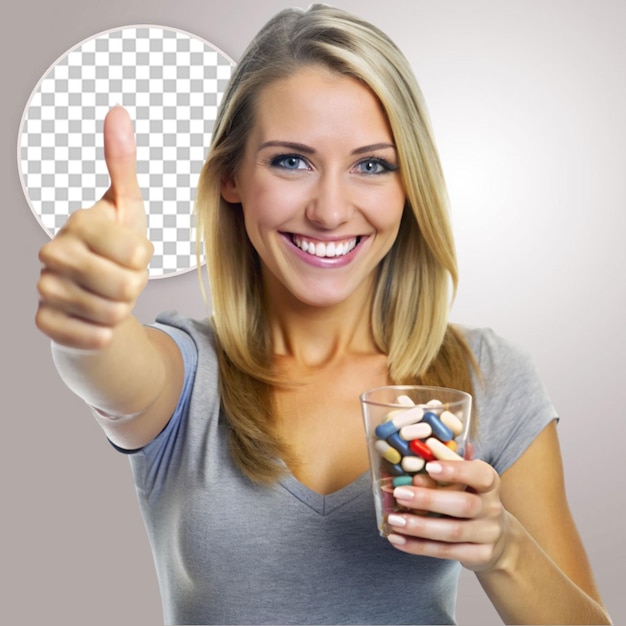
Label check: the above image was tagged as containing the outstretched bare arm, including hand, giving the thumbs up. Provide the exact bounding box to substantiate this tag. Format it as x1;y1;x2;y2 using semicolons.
36;107;183;448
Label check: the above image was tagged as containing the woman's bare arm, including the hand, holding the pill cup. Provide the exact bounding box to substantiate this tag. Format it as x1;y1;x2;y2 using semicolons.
390;423;611;624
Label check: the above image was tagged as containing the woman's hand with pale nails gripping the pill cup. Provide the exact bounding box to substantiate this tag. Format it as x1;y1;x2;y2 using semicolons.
388;460;509;571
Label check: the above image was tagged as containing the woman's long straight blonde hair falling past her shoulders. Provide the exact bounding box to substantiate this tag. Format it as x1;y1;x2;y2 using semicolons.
196;4;471;483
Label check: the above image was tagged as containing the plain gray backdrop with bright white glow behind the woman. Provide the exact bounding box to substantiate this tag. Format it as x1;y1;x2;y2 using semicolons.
0;0;626;626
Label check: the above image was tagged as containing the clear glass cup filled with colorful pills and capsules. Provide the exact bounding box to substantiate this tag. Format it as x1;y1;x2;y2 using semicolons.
360;385;472;537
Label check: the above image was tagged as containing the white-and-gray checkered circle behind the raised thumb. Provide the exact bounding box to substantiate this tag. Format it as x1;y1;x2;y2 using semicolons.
18;26;234;278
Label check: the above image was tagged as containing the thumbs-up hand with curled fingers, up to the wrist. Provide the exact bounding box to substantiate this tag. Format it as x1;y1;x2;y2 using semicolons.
36;107;154;349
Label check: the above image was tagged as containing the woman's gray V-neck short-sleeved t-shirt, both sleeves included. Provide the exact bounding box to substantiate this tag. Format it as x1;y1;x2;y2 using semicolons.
118;312;556;624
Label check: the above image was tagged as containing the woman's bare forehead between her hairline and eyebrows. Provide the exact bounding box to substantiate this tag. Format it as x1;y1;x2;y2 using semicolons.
247;66;392;141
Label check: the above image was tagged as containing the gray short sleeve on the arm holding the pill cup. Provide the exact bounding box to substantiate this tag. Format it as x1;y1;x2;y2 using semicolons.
468;329;558;474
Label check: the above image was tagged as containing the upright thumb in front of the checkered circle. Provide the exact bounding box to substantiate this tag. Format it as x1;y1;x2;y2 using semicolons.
103;106;146;228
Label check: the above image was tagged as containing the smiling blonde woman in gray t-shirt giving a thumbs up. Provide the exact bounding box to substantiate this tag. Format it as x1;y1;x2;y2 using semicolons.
37;5;610;624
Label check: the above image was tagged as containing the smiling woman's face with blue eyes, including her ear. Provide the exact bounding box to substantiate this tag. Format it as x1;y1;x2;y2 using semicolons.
222;66;405;307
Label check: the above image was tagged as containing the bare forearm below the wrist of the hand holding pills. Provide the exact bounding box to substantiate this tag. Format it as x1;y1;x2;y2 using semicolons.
477;515;611;624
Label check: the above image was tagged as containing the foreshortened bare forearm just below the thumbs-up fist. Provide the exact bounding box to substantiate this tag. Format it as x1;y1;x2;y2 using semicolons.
52;317;165;416
